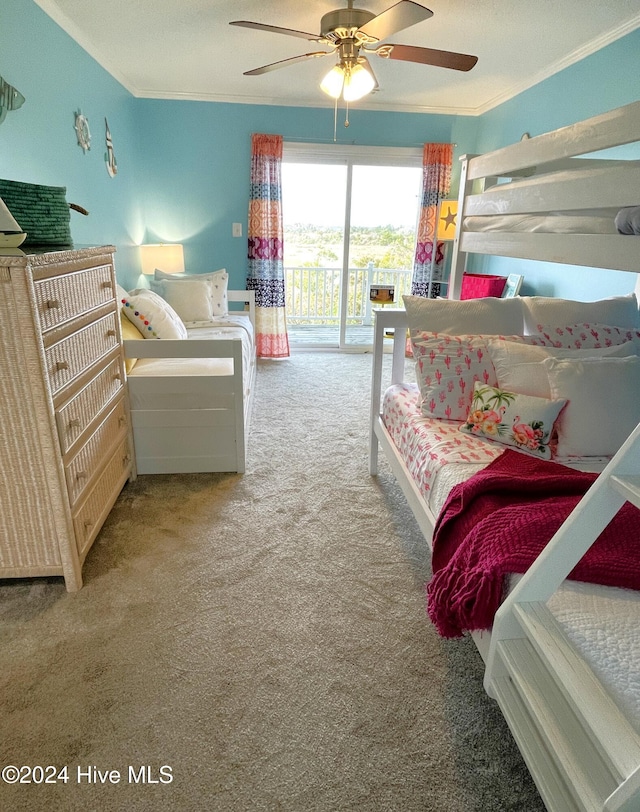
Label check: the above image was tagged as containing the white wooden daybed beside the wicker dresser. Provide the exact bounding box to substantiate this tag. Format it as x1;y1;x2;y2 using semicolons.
124;291;256;474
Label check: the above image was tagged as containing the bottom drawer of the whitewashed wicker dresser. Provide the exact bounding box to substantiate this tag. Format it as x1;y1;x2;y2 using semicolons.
73;438;131;558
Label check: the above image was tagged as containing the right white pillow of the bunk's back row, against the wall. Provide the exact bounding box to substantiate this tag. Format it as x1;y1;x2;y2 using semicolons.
516;293;640;333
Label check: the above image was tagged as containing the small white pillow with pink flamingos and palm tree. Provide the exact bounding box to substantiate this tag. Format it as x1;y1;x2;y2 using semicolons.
460;383;567;460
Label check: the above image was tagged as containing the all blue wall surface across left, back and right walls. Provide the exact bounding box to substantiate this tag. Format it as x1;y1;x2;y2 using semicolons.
0;0;640;298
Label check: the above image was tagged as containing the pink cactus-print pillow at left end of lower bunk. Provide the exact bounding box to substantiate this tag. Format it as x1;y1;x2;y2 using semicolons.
412;332;539;420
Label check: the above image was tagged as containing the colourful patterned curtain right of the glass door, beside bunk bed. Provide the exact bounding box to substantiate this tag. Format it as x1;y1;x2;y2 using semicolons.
411;144;453;299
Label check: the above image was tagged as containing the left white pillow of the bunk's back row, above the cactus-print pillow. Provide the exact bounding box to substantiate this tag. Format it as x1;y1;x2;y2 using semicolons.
402;296;523;335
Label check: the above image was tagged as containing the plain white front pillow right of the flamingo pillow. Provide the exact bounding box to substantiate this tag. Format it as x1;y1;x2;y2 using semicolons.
542;355;640;457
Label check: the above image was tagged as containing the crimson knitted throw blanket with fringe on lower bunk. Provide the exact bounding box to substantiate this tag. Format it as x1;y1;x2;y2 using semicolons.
427;449;640;637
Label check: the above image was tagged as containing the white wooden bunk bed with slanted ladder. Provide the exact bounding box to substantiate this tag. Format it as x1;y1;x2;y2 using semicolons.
370;102;640;812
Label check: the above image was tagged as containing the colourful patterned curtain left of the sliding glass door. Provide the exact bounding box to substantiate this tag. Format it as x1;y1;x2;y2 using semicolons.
247;134;289;358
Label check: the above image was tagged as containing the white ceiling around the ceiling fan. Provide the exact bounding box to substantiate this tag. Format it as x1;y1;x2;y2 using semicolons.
36;0;640;115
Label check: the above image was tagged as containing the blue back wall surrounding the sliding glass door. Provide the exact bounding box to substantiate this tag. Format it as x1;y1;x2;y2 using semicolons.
137;99;476;286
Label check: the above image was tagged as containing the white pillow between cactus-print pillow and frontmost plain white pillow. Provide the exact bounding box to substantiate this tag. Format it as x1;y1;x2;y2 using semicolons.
487;339;636;398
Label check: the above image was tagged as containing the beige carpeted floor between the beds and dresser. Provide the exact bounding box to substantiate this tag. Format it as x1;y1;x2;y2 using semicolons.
0;352;544;812
